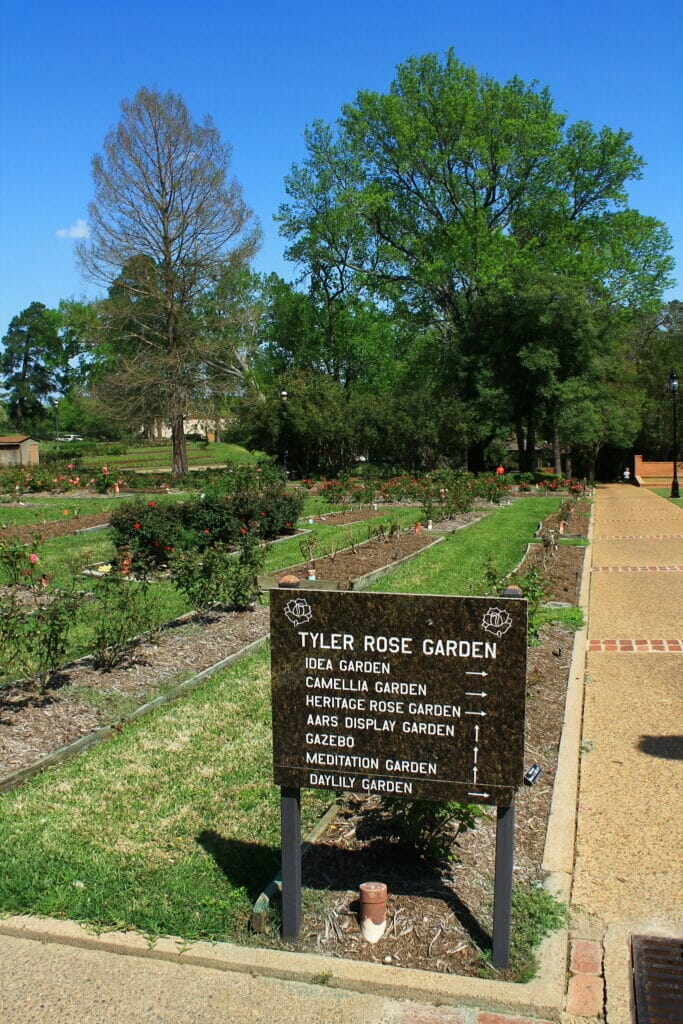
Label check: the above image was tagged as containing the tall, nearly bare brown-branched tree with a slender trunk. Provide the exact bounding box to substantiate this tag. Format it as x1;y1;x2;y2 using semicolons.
78;88;259;476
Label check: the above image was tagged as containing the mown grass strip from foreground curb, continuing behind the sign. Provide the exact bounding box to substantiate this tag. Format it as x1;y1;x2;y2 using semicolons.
0;498;573;940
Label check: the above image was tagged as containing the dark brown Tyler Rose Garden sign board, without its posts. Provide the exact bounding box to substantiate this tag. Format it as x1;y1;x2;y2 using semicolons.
270;590;526;807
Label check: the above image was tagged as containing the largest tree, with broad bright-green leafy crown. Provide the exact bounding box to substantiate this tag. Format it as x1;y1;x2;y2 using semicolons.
279;52;672;462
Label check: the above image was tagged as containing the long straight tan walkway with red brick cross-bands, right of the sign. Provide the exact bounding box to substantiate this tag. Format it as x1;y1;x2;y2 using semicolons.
567;484;683;1024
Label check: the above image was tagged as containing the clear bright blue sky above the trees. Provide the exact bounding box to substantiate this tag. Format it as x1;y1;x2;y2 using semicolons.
0;0;683;337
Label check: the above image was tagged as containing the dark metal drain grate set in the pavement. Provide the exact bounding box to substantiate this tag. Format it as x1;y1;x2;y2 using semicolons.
631;935;683;1024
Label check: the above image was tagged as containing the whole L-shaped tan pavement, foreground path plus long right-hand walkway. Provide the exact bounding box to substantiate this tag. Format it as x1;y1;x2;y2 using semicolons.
0;485;683;1024
